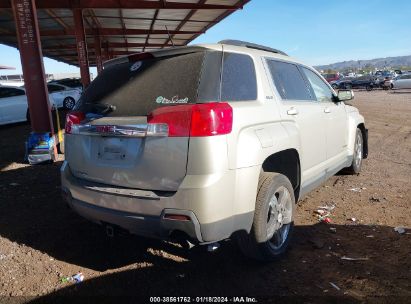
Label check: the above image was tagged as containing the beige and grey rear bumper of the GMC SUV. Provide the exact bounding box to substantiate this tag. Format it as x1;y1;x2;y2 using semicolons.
61;162;254;243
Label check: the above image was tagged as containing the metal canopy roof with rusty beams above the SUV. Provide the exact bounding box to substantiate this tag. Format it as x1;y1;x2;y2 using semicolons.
0;0;250;65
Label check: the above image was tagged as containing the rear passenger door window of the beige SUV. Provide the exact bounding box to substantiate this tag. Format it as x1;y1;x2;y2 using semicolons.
267;59;315;100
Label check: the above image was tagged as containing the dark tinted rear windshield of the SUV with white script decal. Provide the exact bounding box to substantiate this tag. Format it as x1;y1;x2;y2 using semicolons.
77;51;206;116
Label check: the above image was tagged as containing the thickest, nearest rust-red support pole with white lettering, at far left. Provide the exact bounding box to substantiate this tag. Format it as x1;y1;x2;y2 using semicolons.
12;0;54;133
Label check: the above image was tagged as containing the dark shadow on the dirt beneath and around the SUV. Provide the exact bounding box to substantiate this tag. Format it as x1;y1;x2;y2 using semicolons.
0;163;411;303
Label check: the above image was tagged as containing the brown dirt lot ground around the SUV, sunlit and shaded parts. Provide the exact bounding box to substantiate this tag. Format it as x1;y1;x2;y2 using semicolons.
0;91;411;303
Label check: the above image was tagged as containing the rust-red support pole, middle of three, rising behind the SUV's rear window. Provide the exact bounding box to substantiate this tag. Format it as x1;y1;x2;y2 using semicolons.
73;8;90;88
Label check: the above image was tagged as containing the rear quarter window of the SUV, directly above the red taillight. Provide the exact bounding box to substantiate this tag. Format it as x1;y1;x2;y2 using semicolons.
221;52;257;101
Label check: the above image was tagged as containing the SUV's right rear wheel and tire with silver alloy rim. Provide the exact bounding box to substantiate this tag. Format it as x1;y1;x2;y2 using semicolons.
238;172;295;262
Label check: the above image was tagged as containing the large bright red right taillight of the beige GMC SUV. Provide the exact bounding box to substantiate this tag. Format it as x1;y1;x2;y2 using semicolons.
147;102;233;137
